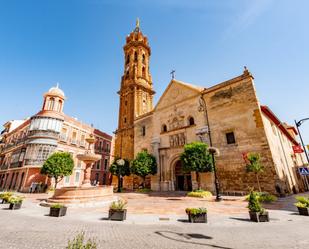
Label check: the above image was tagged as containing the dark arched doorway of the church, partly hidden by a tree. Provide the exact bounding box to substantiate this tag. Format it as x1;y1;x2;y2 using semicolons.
174;160;192;191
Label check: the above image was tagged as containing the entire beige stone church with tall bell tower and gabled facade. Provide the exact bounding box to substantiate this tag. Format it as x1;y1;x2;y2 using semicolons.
115;22;307;194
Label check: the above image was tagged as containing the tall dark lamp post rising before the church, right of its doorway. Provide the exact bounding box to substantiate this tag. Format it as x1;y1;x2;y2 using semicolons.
197;95;222;201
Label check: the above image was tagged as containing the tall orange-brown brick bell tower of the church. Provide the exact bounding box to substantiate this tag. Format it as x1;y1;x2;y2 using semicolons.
115;19;155;159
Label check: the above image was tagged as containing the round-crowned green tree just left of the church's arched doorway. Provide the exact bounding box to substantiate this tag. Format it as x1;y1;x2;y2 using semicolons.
131;150;157;188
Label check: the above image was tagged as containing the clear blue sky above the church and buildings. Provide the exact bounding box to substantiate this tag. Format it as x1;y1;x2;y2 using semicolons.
0;0;309;144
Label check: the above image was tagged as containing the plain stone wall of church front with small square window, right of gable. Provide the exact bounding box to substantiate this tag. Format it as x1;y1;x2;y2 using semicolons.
204;74;276;193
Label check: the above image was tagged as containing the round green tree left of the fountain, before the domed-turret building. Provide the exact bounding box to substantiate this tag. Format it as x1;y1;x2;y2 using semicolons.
41;152;74;189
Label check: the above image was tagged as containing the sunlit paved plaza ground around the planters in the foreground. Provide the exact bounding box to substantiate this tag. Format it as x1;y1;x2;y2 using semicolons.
0;193;309;249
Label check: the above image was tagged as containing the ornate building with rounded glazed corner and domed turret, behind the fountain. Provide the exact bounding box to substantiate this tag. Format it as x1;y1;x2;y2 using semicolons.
0;86;112;192
